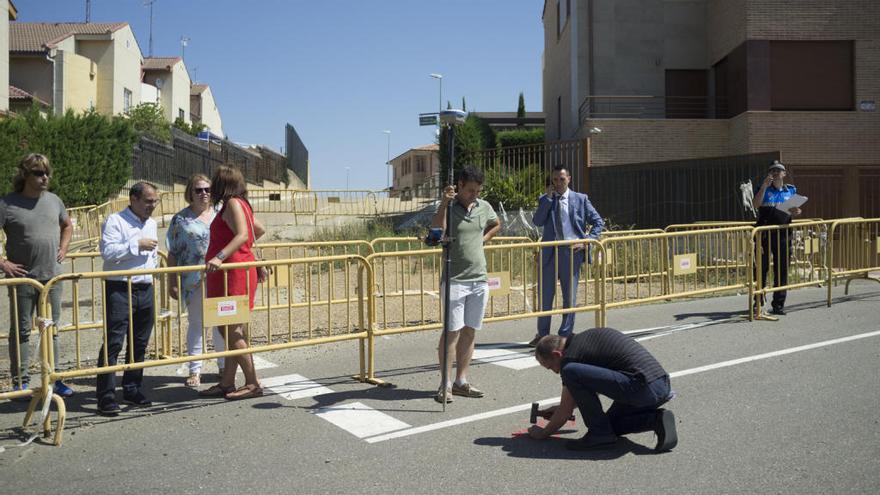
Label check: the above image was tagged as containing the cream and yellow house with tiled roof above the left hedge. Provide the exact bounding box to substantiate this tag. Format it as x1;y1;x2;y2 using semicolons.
9;22;143;115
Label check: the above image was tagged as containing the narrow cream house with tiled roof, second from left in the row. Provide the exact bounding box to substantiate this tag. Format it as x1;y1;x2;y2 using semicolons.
142;57;192;124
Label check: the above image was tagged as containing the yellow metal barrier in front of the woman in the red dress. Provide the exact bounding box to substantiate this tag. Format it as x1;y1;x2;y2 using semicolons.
41;255;376;443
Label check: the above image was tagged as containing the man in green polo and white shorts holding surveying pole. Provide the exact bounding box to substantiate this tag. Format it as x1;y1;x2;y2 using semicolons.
431;165;501;402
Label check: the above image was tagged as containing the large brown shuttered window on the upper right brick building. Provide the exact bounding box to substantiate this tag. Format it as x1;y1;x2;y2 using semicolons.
770;41;855;111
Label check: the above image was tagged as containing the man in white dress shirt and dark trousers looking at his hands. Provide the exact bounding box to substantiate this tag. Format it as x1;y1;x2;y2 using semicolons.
96;182;159;416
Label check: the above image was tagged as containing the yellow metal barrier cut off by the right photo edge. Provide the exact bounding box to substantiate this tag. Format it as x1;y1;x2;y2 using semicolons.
828;218;880;300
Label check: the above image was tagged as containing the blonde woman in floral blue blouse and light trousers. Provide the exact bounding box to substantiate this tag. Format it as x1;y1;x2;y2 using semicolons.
165;174;225;387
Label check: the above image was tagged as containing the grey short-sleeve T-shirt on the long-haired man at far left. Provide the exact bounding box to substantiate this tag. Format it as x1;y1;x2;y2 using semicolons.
0;191;67;281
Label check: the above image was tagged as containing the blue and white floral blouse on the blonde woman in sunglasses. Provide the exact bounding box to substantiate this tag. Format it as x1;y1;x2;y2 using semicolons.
165;206;216;301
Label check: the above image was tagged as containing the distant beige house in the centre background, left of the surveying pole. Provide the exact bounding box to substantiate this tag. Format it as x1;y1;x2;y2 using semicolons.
390;144;440;198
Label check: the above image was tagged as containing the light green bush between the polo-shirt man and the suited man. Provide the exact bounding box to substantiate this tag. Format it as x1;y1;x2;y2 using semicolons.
481;163;544;210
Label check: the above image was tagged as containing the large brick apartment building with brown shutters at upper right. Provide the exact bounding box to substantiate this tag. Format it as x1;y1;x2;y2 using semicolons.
543;0;880;215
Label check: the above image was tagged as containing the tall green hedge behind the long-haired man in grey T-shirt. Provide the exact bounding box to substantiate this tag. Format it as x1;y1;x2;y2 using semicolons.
0;109;137;207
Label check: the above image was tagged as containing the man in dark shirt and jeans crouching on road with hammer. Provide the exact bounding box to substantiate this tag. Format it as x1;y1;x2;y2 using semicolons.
529;328;678;452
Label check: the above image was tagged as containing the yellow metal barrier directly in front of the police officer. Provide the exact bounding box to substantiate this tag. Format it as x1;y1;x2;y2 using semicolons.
749;221;831;320
